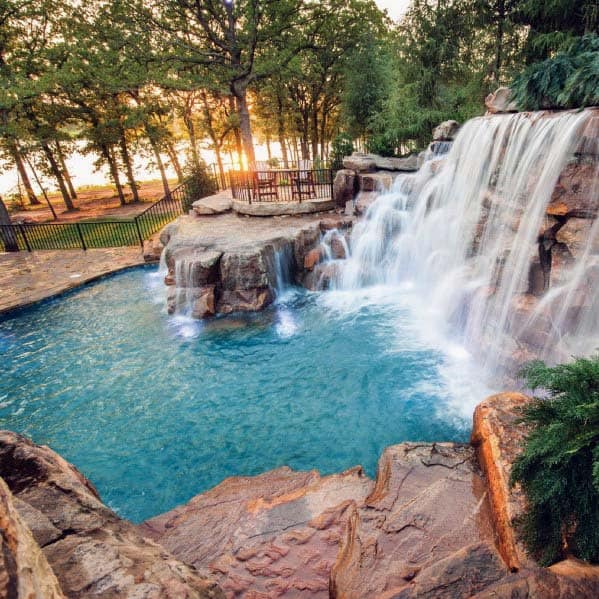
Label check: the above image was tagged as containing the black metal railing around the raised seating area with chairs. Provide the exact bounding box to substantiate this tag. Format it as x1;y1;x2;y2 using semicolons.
229;168;333;204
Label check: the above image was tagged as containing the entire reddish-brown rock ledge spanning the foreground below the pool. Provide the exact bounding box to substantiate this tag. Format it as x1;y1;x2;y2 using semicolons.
0;393;599;599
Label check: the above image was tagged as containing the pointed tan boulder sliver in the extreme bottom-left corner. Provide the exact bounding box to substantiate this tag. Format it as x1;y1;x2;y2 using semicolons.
0;478;64;599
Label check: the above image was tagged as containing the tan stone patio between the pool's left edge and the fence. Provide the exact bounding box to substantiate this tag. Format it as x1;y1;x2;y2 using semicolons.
0;247;144;314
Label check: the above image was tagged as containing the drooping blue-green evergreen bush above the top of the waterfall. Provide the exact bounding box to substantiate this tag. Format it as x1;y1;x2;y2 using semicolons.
512;34;599;110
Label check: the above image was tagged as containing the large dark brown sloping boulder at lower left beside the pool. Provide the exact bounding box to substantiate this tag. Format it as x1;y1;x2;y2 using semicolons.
0;431;224;599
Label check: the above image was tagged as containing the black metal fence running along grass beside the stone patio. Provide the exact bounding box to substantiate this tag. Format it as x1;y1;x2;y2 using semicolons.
0;180;201;252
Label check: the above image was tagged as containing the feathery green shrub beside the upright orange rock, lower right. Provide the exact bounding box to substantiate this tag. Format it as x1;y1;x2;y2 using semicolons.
511;357;599;565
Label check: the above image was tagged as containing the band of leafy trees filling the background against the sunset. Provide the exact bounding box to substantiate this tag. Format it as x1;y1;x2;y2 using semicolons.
0;0;599;208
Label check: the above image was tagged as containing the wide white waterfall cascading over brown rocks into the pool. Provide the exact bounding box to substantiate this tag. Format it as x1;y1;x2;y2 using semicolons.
336;110;599;375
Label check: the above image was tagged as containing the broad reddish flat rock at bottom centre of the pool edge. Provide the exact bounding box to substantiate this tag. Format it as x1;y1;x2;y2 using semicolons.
140;468;372;597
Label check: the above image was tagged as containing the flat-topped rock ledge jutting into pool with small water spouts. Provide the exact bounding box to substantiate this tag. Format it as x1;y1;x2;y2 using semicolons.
161;214;353;318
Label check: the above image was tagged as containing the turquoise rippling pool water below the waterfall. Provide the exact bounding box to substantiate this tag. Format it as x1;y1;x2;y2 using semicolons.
0;268;470;522
